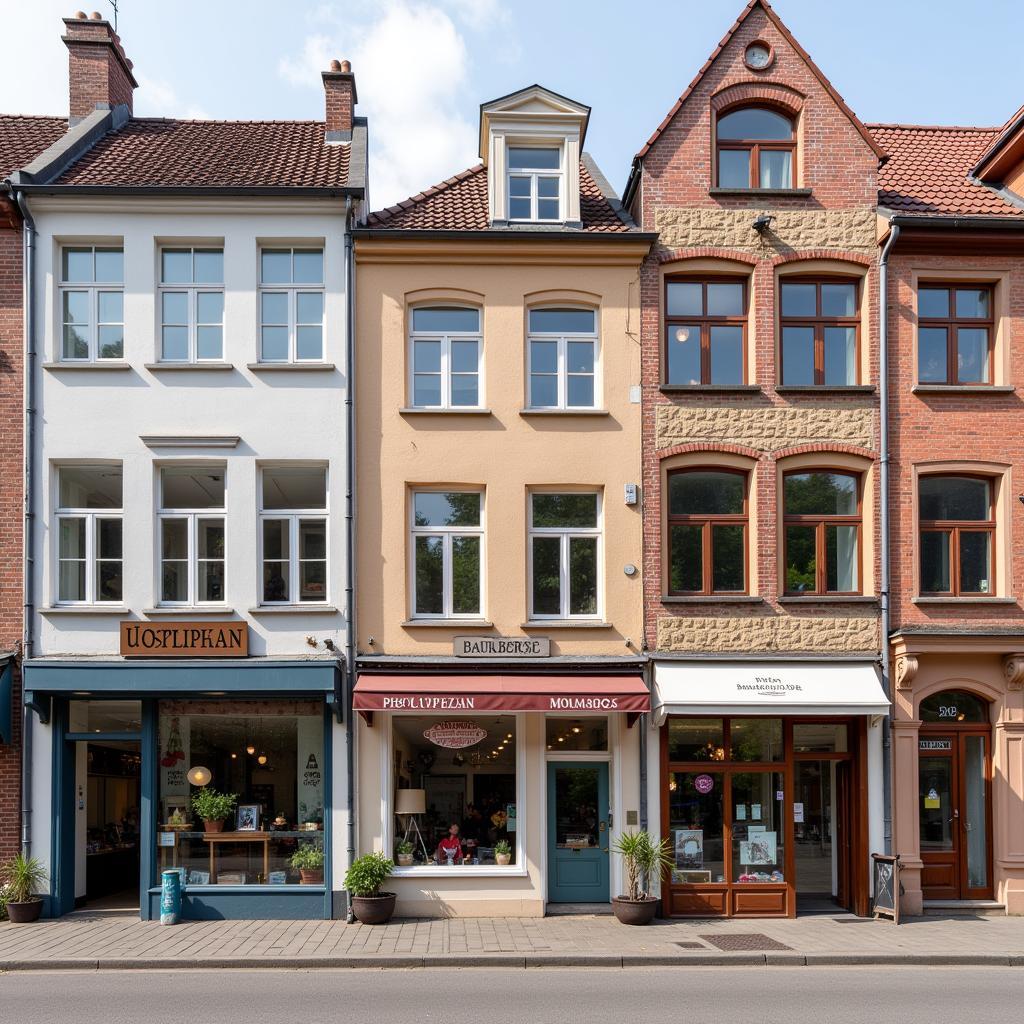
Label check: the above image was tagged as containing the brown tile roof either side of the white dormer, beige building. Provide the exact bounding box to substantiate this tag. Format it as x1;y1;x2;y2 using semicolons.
367;163;635;233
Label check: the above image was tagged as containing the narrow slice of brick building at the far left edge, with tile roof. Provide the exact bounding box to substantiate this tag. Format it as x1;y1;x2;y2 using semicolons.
0;116;68;862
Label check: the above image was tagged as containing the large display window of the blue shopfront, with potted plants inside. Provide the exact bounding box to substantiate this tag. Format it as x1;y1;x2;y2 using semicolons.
157;700;326;886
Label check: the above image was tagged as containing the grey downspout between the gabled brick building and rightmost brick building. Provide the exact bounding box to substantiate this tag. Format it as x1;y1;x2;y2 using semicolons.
879;221;899;854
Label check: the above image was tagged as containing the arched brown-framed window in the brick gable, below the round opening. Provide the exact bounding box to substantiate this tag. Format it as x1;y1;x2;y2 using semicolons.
716;106;797;188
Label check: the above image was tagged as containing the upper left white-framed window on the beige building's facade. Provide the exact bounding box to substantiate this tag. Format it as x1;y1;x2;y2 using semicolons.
410;306;481;409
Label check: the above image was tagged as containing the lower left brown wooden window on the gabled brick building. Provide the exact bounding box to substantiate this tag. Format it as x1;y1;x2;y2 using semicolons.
669;469;749;595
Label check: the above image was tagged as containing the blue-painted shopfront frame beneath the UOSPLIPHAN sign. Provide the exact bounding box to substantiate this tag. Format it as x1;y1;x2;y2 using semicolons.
25;658;344;921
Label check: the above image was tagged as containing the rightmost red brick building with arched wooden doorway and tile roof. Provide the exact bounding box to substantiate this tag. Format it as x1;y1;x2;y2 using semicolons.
871;116;1024;913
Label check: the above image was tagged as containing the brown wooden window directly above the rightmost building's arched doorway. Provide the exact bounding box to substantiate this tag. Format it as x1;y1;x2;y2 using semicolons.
918;475;995;597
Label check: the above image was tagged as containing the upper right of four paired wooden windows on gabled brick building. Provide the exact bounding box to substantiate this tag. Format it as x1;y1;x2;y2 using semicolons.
779;278;860;387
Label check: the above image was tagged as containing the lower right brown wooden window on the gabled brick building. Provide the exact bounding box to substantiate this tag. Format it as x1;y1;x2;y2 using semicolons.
782;469;861;596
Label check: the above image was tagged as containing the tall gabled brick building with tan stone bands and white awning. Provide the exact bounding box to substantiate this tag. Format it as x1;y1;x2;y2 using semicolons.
624;0;888;916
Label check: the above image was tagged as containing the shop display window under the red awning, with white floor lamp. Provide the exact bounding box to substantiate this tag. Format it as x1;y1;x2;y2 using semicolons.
391;715;518;870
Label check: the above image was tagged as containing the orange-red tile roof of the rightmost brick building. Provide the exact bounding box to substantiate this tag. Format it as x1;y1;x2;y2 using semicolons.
868;125;1024;217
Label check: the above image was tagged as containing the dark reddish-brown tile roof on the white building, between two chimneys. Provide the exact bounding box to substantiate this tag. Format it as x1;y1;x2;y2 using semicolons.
55;118;351;188
